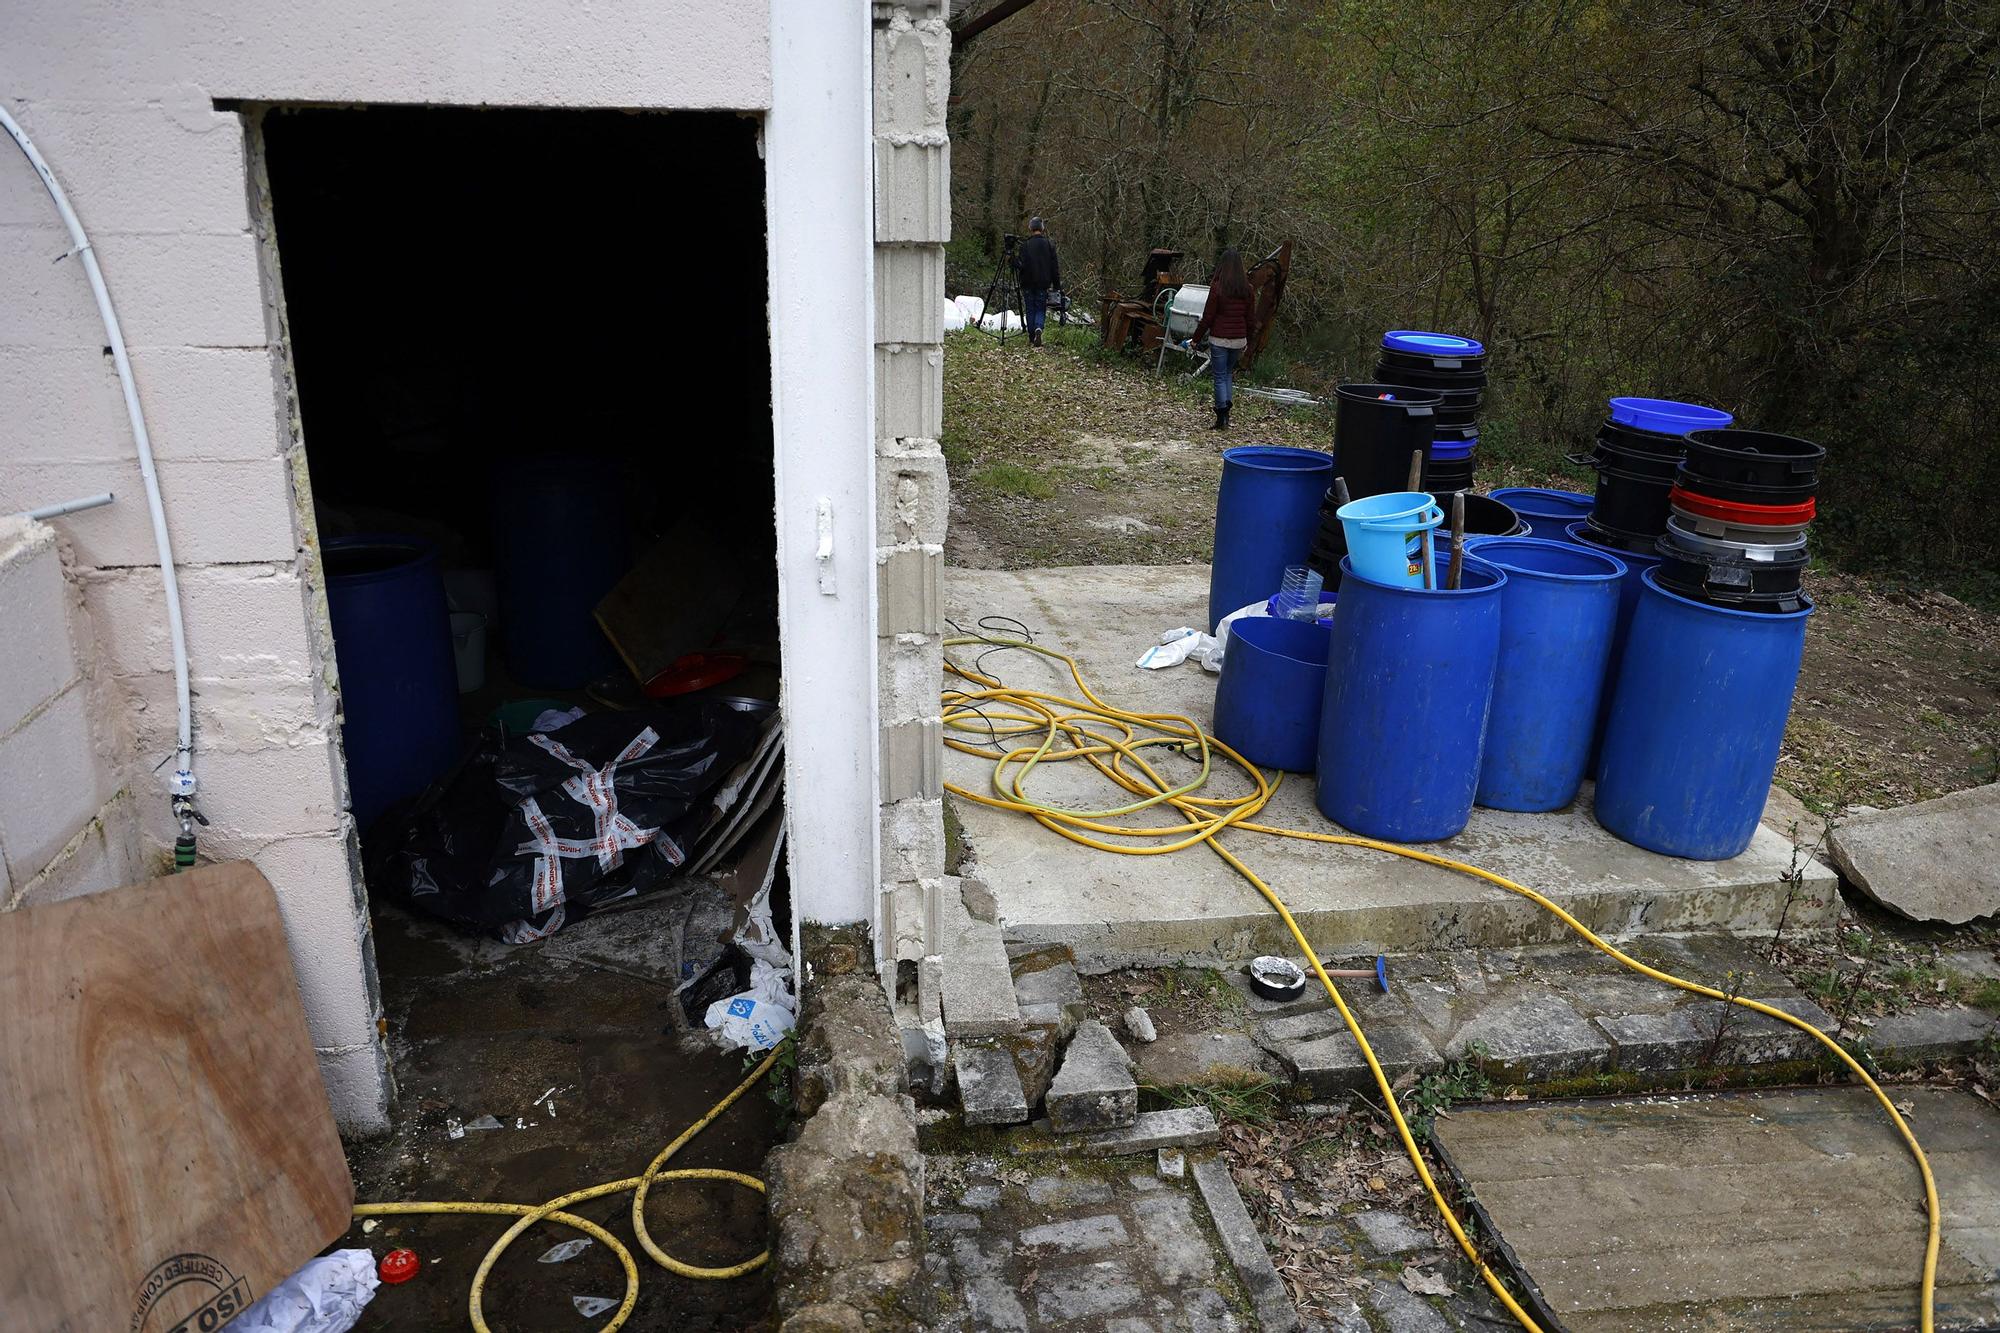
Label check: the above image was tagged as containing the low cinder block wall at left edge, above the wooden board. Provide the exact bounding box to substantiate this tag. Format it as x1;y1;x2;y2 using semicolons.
0;516;149;911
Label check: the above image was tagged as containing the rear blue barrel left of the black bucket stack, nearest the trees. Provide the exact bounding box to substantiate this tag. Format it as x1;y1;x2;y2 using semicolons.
1208;444;1334;628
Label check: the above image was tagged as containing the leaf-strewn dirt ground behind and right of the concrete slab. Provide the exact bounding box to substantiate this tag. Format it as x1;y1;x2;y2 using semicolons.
944;330;2000;807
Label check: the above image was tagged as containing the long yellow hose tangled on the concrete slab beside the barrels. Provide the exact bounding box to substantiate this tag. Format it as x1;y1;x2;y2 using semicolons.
936;634;1940;1333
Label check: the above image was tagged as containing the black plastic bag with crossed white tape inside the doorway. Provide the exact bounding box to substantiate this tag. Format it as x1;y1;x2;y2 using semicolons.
368;701;758;945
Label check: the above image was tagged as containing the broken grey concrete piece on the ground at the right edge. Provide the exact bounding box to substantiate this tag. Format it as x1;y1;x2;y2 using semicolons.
1828;783;2000;925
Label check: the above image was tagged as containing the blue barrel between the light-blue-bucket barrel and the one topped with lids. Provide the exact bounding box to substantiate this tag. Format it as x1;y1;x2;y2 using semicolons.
1474;536;1626;811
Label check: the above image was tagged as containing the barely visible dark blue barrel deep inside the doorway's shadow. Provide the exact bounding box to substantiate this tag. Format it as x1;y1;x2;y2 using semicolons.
494;458;632;691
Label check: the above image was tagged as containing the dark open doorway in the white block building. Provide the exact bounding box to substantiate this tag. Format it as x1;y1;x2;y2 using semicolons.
258;108;788;1327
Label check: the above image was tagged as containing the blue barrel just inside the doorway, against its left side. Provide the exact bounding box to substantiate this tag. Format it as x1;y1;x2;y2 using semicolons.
322;536;458;827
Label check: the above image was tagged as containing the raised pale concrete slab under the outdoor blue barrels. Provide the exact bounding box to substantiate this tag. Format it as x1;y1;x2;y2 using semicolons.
946;566;1838;971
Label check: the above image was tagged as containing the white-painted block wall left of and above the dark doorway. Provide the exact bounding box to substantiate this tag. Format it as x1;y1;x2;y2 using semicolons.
0;0;772;1129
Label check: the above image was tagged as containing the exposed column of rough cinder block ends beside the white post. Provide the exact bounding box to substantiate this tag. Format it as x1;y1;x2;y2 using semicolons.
874;2;952;959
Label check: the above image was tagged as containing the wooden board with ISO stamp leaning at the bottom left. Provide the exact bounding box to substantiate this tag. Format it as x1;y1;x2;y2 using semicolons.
0;863;354;1333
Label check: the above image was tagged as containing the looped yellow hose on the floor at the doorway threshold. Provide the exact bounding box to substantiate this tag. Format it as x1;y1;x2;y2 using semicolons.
354;1045;784;1333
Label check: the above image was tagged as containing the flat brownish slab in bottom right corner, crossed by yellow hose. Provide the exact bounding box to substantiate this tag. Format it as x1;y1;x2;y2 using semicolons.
1436;1087;2000;1333
